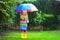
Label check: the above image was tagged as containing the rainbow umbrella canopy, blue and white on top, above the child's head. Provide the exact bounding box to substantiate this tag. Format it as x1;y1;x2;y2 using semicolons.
16;4;38;12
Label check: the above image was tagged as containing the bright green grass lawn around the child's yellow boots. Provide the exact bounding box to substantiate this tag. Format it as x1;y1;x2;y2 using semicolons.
0;31;60;40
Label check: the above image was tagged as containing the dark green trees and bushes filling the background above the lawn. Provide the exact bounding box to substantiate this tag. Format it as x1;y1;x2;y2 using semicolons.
0;0;60;30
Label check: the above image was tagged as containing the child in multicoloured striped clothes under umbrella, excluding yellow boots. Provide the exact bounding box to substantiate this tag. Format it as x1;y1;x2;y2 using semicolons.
20;11;29;32
